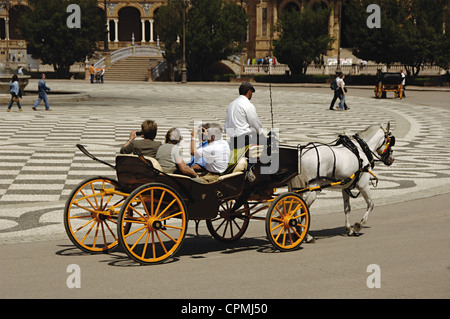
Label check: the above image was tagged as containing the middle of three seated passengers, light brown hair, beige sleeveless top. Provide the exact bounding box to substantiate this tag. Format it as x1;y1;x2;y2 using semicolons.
156;127;197;177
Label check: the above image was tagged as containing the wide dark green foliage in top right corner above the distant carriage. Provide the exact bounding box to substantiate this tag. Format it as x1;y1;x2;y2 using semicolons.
343;0;450;76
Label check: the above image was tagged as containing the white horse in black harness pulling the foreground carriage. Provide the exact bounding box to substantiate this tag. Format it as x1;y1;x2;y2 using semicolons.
289;123;395;242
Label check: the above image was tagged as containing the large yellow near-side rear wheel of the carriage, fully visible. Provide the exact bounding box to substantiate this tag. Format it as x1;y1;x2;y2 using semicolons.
117;183;188;264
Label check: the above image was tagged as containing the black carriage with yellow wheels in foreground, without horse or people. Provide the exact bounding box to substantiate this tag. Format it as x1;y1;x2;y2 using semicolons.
64;145;310;264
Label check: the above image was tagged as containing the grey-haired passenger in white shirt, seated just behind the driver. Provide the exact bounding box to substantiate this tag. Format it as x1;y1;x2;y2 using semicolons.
191;124;230;181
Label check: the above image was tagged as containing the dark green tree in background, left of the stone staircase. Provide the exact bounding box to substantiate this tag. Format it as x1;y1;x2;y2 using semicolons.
19;0;104;77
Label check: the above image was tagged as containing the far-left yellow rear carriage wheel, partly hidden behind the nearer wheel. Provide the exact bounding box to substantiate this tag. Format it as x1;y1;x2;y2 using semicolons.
64;177;128;253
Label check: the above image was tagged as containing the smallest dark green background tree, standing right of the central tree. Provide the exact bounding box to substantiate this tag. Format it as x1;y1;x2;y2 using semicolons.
273;6;332;74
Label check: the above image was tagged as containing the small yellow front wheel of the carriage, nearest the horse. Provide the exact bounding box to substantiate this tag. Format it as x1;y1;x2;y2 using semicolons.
266;193;310;251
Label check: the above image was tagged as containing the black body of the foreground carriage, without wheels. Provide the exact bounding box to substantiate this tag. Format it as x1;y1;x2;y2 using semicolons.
116;147;298;220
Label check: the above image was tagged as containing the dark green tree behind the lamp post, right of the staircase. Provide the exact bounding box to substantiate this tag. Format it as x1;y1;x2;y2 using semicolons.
155;0;247;80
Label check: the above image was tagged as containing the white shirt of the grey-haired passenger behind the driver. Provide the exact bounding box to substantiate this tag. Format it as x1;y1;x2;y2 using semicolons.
197;140;230;173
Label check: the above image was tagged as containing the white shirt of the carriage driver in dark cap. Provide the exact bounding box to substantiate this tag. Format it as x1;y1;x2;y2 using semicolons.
225;95;262;137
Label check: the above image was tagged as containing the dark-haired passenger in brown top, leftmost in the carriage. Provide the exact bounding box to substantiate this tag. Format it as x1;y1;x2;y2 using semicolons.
120;120;162;157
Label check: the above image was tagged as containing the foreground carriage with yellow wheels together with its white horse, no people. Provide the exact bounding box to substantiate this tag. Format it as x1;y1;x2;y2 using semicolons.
64;125;395;264
